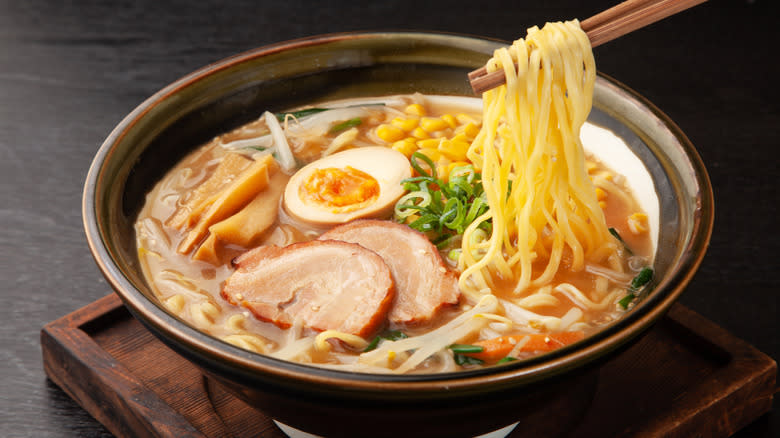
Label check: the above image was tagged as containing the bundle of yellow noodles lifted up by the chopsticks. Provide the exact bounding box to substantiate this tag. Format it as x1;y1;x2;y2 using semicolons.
459;20;616;297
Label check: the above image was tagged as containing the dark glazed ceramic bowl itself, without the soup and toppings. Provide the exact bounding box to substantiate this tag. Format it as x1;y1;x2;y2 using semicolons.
83;33;713;437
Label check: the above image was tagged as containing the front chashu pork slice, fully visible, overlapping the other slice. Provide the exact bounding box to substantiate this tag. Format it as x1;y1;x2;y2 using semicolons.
222;240;395;337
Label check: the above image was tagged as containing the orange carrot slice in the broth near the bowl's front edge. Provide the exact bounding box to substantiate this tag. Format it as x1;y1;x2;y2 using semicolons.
464;331;585;362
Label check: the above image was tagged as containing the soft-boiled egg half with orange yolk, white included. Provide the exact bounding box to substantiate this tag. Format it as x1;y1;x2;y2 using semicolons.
284;146;412;227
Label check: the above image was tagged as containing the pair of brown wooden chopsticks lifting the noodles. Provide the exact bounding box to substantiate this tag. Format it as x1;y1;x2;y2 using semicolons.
468;0;707;94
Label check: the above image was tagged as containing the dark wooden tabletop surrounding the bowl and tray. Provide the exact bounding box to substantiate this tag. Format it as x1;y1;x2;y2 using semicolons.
0;0;780;437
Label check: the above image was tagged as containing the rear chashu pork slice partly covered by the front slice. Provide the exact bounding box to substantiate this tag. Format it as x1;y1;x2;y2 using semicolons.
320;219;460;324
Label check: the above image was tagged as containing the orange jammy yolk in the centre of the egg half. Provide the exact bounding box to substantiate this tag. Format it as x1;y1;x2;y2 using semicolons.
299;166;379;211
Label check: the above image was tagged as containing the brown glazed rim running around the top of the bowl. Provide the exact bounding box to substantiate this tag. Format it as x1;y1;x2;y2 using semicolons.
82;31;714;394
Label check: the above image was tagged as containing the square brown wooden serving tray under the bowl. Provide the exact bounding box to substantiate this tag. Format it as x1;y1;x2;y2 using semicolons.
41;294;777;438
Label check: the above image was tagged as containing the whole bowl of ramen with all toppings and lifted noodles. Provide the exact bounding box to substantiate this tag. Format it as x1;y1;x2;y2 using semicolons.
83;28;713;436
